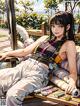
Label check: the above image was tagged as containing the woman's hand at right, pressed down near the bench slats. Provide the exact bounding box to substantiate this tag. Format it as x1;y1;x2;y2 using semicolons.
65;77;76;94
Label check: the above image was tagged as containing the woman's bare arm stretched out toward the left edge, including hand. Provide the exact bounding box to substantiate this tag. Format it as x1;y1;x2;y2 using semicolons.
0;36;48;60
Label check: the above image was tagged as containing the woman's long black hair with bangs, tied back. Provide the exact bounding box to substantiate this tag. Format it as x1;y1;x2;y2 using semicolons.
50;11;75;40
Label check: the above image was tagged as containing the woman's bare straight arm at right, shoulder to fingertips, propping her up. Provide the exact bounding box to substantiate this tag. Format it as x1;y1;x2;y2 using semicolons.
66;41;77;93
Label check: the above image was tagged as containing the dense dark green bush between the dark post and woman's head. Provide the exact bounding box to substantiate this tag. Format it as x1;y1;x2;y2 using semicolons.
16;13;47;29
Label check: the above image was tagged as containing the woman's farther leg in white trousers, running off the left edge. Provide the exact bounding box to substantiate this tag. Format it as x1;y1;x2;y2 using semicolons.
0;60;26;96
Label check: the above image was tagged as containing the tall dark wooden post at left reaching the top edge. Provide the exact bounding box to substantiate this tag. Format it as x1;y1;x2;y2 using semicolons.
9;0;17;50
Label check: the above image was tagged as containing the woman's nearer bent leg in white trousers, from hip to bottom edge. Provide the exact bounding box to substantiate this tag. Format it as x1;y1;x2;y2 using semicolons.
6;59;48;106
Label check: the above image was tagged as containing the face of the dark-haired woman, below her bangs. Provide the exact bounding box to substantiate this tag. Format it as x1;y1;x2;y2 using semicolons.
51;24;64;39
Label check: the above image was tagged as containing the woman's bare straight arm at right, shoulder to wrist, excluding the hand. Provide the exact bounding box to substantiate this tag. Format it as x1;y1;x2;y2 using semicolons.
66;41;77;82
